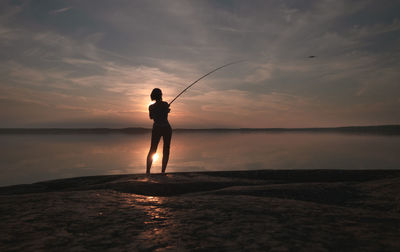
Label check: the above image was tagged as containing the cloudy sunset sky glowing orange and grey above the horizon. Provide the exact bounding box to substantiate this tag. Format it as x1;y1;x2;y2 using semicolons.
0;0;400;128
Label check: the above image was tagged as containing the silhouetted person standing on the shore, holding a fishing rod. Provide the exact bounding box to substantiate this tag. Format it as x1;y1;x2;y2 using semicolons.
146;88;172;175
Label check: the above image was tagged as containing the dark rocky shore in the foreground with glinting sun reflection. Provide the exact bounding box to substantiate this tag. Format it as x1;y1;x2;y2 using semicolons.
0;170;400;251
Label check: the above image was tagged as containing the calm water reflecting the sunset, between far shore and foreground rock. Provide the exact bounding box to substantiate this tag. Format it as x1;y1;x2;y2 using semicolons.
0;133;400;186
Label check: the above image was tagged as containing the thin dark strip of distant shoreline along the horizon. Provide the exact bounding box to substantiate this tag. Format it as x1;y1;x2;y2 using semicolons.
0;125;400;135
